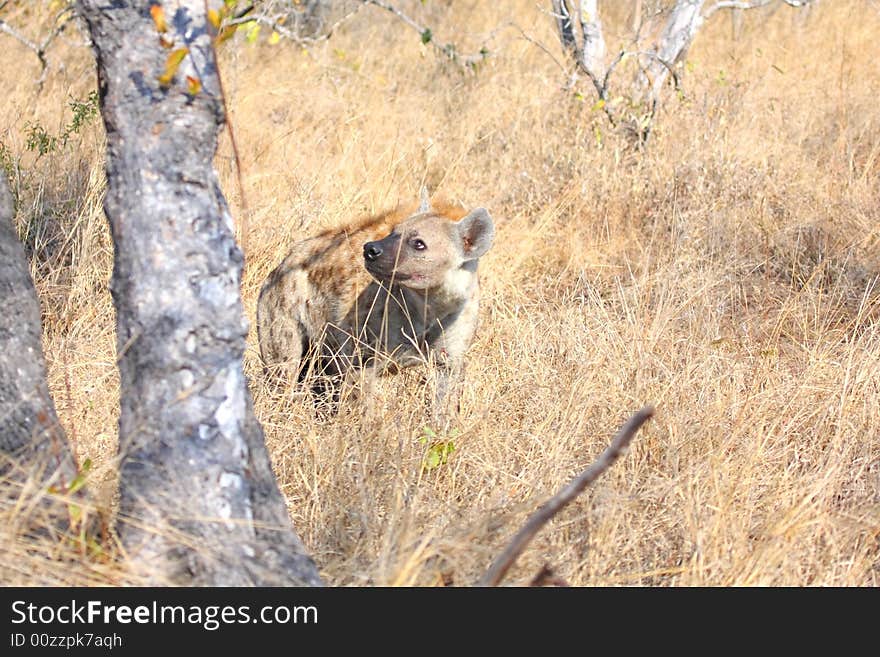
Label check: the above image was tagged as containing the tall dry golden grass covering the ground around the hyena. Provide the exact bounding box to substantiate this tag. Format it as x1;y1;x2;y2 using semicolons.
0;0;880;585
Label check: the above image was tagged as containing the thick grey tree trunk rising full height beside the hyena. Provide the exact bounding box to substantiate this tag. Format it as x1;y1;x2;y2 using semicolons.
80;0;321;586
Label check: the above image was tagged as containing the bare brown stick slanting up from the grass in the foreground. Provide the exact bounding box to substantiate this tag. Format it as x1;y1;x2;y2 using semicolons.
480;406;654;586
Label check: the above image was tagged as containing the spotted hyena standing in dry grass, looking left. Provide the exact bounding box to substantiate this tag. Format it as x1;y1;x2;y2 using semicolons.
257;189;495;413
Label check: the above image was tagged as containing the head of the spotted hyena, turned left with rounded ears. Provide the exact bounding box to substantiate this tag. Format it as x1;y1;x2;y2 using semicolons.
364;192;495;290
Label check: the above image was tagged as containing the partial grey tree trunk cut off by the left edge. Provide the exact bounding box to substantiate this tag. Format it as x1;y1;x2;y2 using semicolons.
0;173;75;488
